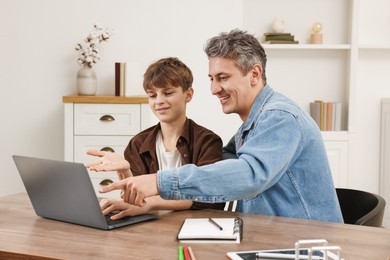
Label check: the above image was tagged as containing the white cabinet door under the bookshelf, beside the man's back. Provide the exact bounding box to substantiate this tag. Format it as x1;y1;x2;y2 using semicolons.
325;141;348;188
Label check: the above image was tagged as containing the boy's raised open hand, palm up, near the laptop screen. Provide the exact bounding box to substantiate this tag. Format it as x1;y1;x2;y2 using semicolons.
85;150;133;180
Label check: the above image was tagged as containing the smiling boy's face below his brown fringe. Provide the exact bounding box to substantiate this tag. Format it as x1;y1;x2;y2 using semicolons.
146;85;194;123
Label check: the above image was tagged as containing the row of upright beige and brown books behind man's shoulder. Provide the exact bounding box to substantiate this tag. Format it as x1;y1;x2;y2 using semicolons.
310;100;341;131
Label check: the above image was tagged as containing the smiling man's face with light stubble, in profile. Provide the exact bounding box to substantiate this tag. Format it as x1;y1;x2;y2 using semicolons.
209;57;253;121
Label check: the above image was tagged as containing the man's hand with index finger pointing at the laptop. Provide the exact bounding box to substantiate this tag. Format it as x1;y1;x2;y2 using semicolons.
100;173;158;207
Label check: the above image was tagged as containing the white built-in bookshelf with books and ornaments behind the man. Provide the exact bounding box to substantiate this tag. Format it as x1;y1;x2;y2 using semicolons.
243;0;362;187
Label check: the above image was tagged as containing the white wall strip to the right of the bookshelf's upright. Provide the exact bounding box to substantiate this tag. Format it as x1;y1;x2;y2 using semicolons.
350;0;390;192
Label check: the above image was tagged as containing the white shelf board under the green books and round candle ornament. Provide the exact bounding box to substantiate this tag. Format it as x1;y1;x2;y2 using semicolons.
262;44;351;50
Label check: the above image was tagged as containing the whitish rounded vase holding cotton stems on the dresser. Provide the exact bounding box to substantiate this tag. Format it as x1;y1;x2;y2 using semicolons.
77;65;97;96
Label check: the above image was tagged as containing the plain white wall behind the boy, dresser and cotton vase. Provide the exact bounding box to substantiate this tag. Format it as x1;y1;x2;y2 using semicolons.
0;0;243;196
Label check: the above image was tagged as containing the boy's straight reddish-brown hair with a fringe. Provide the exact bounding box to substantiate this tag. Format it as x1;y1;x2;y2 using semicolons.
144;57;193;91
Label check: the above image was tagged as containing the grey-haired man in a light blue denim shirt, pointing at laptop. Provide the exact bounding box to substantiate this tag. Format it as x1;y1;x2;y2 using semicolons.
101;30;343;222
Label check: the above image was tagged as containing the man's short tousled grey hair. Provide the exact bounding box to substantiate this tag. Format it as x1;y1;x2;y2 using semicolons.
204;29;267;84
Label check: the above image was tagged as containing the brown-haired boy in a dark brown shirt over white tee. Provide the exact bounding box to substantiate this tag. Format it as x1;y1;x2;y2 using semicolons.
86;58;225;219
